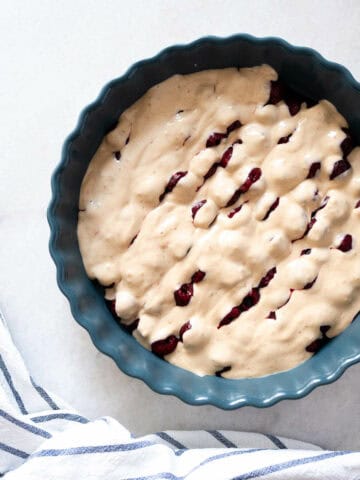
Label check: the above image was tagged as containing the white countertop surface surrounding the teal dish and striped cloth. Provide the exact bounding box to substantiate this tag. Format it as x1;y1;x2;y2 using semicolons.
0;0;360;449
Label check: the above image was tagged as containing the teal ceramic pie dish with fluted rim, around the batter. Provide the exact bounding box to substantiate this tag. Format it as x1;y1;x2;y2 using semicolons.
48;35;360;409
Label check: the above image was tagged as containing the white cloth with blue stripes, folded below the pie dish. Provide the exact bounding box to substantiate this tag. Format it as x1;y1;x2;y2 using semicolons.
0;313;360;480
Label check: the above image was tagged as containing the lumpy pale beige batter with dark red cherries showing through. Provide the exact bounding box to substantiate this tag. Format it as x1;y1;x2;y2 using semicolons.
78;65;360;378
